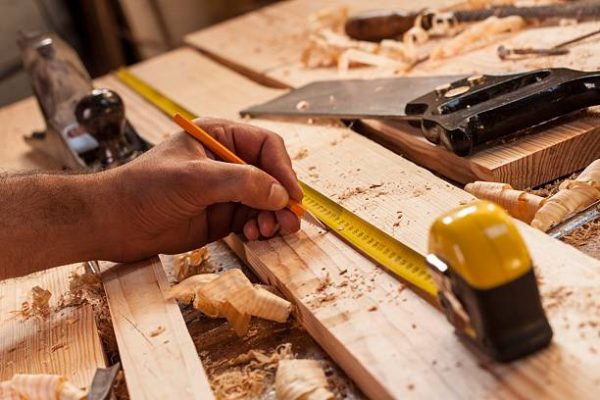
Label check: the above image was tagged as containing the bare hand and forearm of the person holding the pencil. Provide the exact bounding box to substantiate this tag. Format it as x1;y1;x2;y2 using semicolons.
0;119;302;279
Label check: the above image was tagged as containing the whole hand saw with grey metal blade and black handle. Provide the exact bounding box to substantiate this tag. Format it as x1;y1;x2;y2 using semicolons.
241;68;600;156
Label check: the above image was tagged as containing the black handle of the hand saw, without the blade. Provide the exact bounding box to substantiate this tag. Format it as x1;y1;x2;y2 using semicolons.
406;68;600;156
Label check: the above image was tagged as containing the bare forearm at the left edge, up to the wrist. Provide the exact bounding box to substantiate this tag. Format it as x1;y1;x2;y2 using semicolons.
0;174;112;279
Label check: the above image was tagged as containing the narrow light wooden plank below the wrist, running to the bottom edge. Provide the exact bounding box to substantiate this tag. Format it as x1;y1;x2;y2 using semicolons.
102;257;213;399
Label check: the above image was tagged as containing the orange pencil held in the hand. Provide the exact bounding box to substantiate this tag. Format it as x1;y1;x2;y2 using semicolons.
173;113;324;227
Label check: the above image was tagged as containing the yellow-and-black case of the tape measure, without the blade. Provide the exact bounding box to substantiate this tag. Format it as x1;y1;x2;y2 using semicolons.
427;201;552;362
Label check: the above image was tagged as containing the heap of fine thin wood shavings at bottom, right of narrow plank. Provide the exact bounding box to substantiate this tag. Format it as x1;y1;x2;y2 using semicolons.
208;343;294;400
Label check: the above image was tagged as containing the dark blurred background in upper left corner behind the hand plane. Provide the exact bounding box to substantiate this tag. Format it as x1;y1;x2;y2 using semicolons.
0;0;275;106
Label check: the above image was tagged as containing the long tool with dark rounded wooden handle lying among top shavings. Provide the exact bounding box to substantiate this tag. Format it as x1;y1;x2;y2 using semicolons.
345;1;600;42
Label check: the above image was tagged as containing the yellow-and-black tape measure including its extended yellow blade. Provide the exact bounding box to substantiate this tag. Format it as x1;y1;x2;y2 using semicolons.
118;70;552;361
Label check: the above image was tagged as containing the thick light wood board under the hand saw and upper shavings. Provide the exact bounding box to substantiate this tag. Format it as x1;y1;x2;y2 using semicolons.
186;0;600;188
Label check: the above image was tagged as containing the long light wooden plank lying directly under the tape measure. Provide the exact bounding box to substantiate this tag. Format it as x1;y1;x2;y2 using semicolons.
126;48;600;399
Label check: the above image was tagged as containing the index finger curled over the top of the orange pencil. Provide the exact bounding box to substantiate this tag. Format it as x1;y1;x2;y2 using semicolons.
195;119;303;201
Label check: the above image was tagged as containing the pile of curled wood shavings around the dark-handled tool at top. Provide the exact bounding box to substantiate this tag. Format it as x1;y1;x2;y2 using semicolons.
301;0;526;74
